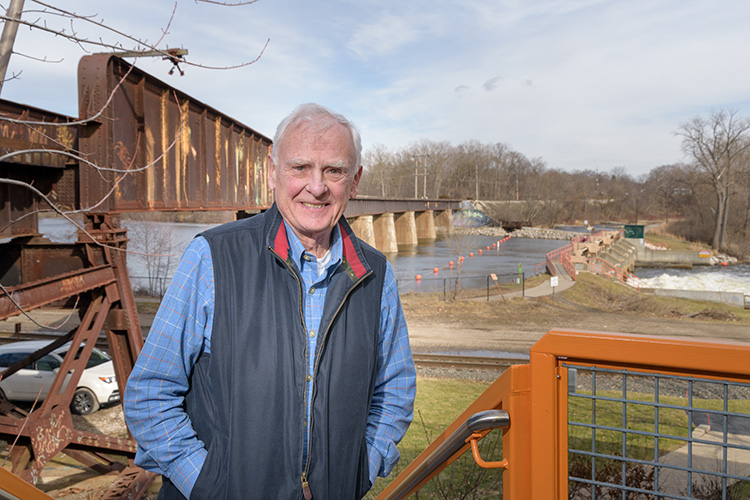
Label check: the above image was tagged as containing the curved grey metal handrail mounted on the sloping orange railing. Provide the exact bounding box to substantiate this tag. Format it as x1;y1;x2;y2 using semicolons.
382;410;510;500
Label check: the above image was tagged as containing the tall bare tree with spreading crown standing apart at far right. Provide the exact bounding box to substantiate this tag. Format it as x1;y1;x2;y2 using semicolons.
676;110;750;250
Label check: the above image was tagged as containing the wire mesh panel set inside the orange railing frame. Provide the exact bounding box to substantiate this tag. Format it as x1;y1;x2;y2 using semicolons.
564;364;750;500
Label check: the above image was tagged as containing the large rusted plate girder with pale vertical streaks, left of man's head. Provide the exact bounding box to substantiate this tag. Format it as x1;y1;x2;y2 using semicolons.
78;54;272;212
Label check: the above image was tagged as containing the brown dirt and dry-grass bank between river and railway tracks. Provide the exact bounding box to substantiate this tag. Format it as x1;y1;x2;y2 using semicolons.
402;274;750;354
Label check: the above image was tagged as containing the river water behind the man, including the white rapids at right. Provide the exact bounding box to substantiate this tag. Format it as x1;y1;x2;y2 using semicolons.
39;219;750;294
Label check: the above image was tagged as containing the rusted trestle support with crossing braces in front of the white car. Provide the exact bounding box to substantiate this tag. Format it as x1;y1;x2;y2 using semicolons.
0;214;155;499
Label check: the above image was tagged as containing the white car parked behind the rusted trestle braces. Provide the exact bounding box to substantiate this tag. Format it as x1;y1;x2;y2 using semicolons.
0;340;120;415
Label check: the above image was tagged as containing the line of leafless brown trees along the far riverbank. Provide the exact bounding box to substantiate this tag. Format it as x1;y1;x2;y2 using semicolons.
360;110;750;255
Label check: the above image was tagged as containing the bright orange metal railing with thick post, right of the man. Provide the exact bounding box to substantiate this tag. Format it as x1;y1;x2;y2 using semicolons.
377;330;750;500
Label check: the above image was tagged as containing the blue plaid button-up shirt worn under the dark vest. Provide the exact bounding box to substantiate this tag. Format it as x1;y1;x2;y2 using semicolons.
123;227;416;498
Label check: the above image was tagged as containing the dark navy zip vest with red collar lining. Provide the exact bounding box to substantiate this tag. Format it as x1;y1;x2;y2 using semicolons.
159;205;386;500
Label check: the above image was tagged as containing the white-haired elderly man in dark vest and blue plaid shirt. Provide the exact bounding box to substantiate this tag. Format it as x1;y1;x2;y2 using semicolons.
124;104;415;500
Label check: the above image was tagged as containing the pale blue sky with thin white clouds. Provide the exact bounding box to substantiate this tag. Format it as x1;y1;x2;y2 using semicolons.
0;0;750;177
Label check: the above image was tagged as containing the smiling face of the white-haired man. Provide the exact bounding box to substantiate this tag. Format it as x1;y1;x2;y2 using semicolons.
268;123;362;256
